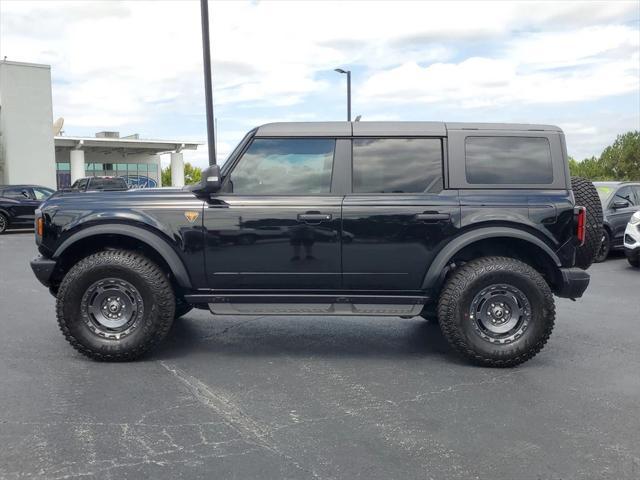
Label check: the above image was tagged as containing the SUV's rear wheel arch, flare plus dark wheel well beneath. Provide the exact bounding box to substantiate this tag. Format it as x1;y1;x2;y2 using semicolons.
422;227;562;289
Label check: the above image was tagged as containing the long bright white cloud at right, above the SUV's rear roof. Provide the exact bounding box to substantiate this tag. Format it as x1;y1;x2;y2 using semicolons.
360;26;640;108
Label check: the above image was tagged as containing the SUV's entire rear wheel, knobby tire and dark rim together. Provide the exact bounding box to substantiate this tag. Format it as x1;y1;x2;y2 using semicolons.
438;257;555;367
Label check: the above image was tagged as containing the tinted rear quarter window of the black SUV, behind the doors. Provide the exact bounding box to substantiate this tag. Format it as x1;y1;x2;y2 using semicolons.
465;136;553;185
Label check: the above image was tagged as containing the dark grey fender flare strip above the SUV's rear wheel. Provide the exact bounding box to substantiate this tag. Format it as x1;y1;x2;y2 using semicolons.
422;227;562;289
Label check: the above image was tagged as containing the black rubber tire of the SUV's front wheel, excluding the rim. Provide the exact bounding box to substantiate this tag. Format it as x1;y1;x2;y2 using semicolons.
56;250;176;361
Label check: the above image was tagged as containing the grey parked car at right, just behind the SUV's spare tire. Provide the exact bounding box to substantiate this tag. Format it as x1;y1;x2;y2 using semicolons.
593;182;640;262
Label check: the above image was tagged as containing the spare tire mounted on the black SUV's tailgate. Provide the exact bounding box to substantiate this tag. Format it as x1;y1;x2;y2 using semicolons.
571;177;602;270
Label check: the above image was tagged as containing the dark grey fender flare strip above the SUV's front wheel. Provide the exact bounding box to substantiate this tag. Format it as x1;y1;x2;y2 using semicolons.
53;223;192;289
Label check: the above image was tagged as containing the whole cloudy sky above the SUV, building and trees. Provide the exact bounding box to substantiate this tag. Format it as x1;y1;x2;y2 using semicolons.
0;0;640;166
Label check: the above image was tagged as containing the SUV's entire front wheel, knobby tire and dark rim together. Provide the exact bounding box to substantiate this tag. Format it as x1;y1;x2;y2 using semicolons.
56;250;175;361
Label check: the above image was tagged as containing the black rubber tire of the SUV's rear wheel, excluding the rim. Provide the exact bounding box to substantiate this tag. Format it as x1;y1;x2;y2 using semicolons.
438;257;555;367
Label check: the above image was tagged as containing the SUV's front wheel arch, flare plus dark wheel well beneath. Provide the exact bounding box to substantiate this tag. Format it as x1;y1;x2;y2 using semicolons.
53;223;192;289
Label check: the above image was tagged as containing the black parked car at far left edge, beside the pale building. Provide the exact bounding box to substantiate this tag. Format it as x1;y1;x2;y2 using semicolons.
0;185;55;234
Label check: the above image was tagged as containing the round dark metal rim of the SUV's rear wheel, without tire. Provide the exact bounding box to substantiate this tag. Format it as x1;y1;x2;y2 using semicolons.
469;283;531;344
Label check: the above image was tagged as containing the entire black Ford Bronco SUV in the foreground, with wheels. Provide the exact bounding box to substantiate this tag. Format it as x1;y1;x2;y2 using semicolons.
31;122;602;367
